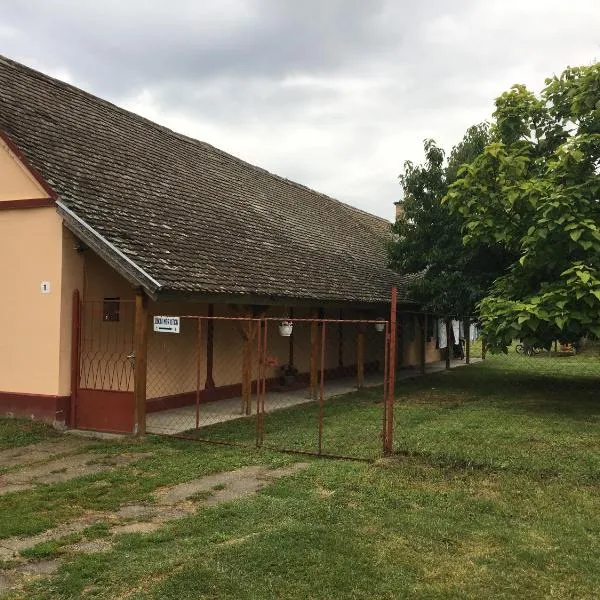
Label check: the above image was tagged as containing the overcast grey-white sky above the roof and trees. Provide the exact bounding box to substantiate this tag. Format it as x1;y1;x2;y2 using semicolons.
0;0;600;218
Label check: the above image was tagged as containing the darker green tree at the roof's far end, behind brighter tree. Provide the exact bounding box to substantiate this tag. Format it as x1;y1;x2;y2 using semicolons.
389;123;507;316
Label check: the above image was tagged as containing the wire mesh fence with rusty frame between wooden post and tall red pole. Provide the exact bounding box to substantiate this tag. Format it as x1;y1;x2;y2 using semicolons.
146;316;388;458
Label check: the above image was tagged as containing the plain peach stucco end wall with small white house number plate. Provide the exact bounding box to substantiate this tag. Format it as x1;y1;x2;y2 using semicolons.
0;208;80;396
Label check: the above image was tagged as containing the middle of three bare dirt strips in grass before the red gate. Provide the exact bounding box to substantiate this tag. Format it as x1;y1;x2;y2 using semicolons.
0;452;147;495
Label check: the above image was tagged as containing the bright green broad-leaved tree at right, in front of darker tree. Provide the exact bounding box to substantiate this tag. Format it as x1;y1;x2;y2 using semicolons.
444;63;600;351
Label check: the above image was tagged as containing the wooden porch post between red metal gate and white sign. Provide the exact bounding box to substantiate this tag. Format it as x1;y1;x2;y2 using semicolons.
133;289;148;436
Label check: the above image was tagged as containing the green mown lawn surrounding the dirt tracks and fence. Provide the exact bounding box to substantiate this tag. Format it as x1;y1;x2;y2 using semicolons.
0;352;600;600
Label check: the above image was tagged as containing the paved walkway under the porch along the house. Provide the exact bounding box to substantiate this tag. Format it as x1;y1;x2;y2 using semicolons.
146;359;480;435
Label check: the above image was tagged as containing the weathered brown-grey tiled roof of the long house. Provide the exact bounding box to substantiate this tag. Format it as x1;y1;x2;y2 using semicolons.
0;56;410;303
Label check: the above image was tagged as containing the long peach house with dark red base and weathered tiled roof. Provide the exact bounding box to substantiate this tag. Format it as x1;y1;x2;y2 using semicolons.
0;57;439;431
